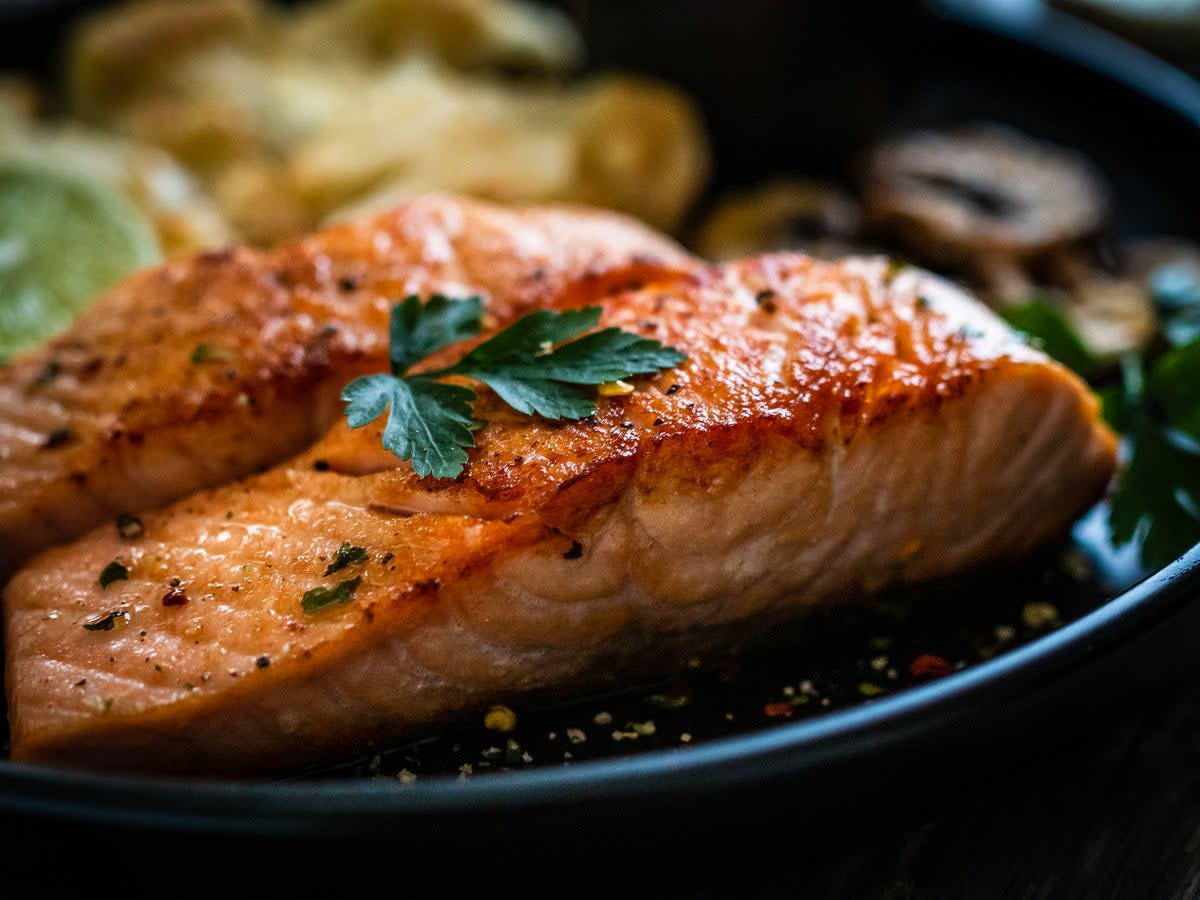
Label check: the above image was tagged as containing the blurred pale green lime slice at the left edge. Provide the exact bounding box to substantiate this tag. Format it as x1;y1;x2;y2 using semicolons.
0;161;162;359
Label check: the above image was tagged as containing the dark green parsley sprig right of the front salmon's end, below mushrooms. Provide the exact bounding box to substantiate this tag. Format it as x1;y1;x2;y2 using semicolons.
1001;285;1200;569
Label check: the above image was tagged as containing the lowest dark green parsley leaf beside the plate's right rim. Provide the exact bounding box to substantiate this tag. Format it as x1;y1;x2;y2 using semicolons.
1109;415;1200;569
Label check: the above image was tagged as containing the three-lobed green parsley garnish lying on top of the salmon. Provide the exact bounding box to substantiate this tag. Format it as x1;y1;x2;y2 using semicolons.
342;294;686;478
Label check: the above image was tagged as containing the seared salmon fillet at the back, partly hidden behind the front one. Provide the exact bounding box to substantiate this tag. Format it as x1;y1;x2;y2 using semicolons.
0;196;686;582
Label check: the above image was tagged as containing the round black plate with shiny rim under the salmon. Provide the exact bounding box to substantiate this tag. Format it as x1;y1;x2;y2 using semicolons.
0;2;1200;868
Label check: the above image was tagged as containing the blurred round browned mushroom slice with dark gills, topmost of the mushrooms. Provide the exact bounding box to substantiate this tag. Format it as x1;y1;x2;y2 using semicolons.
863;125;1108;274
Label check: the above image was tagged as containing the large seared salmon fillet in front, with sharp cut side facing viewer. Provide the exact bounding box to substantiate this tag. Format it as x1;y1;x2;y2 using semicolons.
5;254;1116;773
